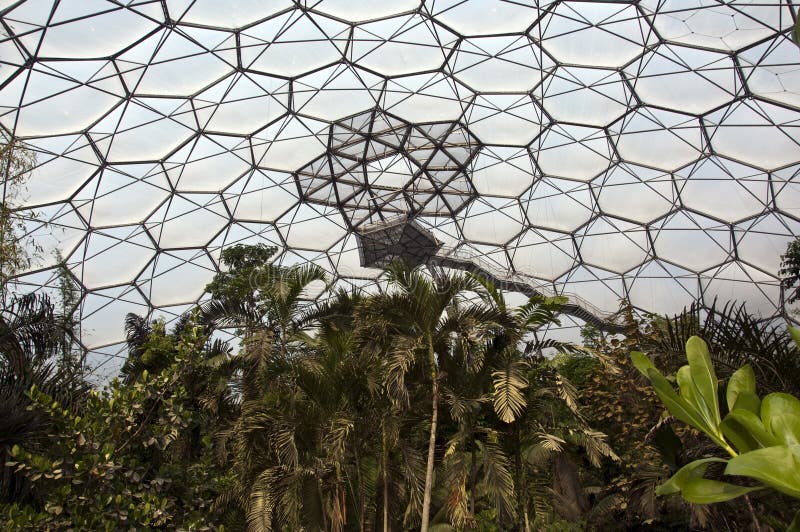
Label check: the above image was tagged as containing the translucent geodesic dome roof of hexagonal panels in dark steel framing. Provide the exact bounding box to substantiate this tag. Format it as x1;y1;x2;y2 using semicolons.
0;0;800;374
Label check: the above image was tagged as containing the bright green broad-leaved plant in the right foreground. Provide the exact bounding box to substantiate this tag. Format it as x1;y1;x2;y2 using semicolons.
631;330;800;529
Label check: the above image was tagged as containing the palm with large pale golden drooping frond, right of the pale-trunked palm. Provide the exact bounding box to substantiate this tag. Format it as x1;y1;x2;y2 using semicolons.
478;278;616;530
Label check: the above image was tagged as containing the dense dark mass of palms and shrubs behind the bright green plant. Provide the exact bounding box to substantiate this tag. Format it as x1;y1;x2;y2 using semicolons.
0;246;800;531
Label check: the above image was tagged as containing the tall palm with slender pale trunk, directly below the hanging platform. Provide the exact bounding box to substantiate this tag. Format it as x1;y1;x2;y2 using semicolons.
362;263;500;532
